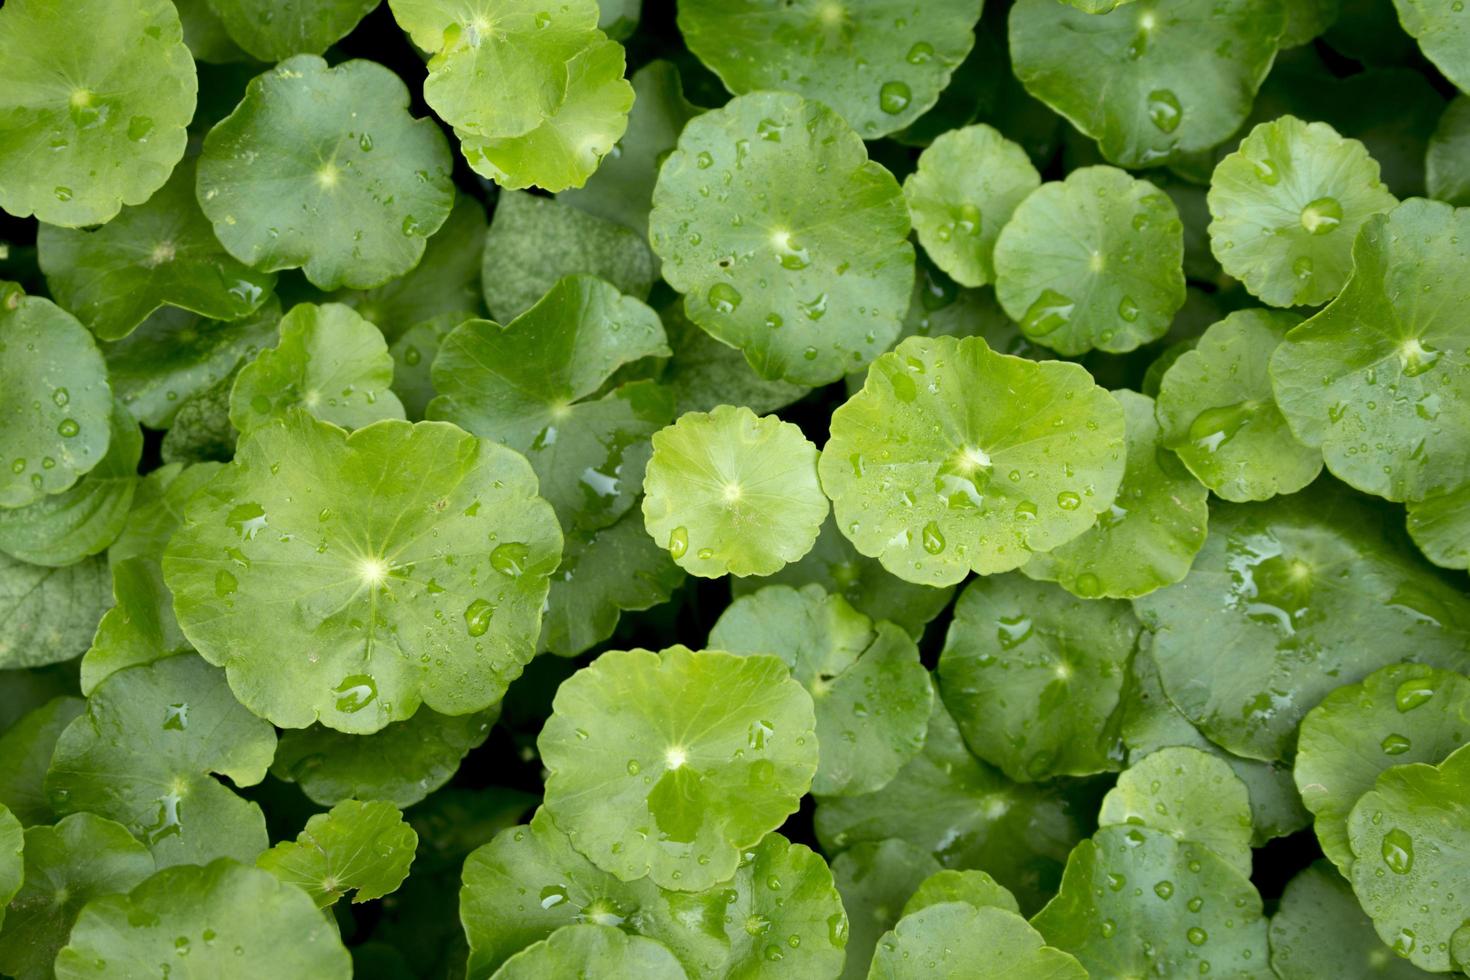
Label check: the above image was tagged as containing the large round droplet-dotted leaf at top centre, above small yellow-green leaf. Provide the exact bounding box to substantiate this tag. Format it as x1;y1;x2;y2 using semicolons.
648;93;914;385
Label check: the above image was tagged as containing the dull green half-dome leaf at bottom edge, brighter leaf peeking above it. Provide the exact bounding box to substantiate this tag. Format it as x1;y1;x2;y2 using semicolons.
867;902;1088;980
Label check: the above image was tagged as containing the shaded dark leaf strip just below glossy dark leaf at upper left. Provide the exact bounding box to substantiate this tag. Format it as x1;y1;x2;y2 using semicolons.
101;297;281;429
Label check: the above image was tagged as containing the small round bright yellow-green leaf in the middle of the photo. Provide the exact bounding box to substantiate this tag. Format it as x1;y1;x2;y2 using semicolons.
642;406;828;579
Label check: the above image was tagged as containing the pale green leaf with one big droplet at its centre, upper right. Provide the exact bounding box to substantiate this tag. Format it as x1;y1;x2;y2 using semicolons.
1208;116;1398;306
